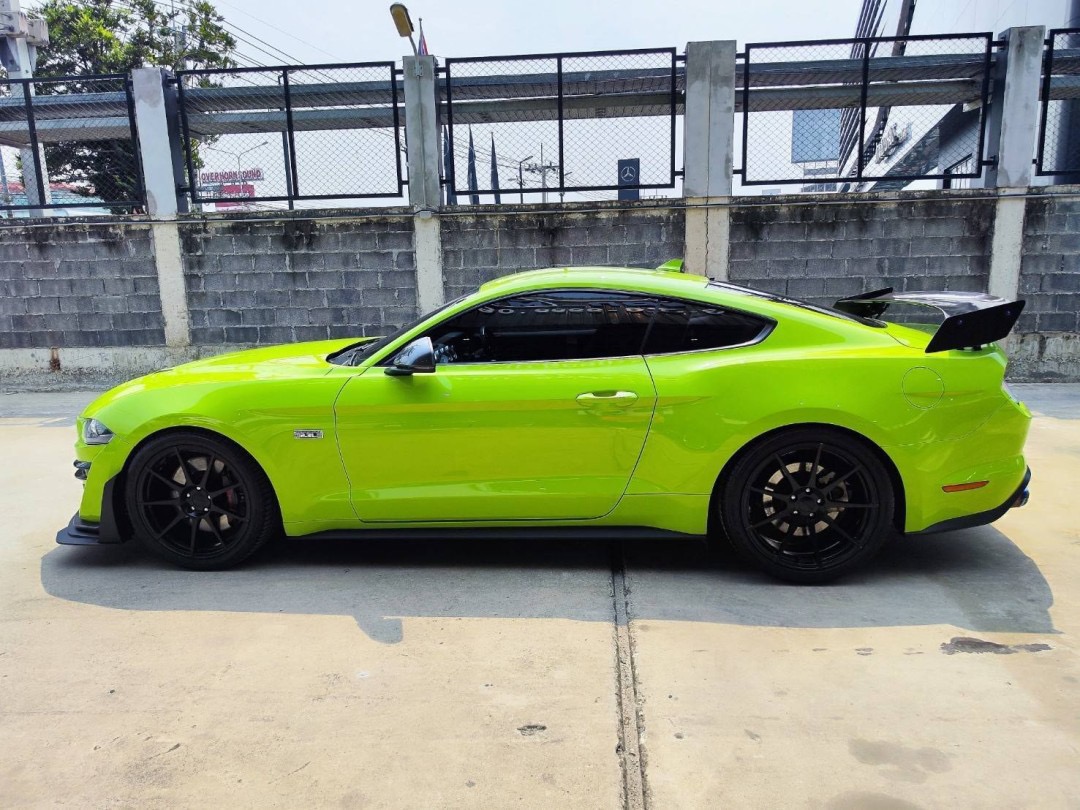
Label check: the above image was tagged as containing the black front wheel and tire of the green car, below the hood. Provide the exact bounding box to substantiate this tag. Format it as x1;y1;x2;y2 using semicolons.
124;431;281;571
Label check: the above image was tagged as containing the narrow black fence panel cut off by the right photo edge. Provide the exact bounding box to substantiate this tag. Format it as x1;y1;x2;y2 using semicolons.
1035;28;1080;181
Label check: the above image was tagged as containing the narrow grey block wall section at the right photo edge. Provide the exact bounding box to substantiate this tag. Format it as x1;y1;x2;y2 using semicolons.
1020;197;1080;332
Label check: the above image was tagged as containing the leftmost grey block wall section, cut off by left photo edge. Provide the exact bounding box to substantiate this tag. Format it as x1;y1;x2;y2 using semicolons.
0;221;164;349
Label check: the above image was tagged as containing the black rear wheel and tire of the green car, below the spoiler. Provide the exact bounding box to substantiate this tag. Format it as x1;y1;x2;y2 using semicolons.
716;428;895;583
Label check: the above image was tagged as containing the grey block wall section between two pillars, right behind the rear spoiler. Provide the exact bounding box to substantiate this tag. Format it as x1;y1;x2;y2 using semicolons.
729;193;995;303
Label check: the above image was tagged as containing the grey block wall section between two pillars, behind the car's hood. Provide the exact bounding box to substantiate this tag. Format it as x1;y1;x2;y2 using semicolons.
180;213;417;346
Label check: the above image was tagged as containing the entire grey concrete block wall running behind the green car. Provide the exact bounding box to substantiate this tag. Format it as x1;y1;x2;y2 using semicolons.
0;193;1080;379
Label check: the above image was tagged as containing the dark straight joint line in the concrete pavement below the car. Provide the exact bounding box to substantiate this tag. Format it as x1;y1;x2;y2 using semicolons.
610;542;649;810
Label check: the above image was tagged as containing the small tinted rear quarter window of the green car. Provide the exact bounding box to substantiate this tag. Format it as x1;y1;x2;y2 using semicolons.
643;298;769;354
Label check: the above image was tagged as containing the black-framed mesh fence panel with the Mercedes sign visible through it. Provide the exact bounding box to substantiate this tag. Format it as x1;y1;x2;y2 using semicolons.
441;48;685;202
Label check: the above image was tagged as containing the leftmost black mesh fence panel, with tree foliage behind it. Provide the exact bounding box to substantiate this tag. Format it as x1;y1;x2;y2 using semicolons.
0;75;145;216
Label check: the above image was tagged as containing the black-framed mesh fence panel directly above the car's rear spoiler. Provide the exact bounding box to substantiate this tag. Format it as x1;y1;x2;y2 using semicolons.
735;33;999;191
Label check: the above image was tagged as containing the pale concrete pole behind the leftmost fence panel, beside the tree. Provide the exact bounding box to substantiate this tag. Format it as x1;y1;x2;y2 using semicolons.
0;0;53;216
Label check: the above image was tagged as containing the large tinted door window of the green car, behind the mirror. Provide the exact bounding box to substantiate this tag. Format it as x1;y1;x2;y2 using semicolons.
428;289;654;363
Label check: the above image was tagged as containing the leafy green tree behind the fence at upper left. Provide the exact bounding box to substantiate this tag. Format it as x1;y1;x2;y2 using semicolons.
27;0;237;209
